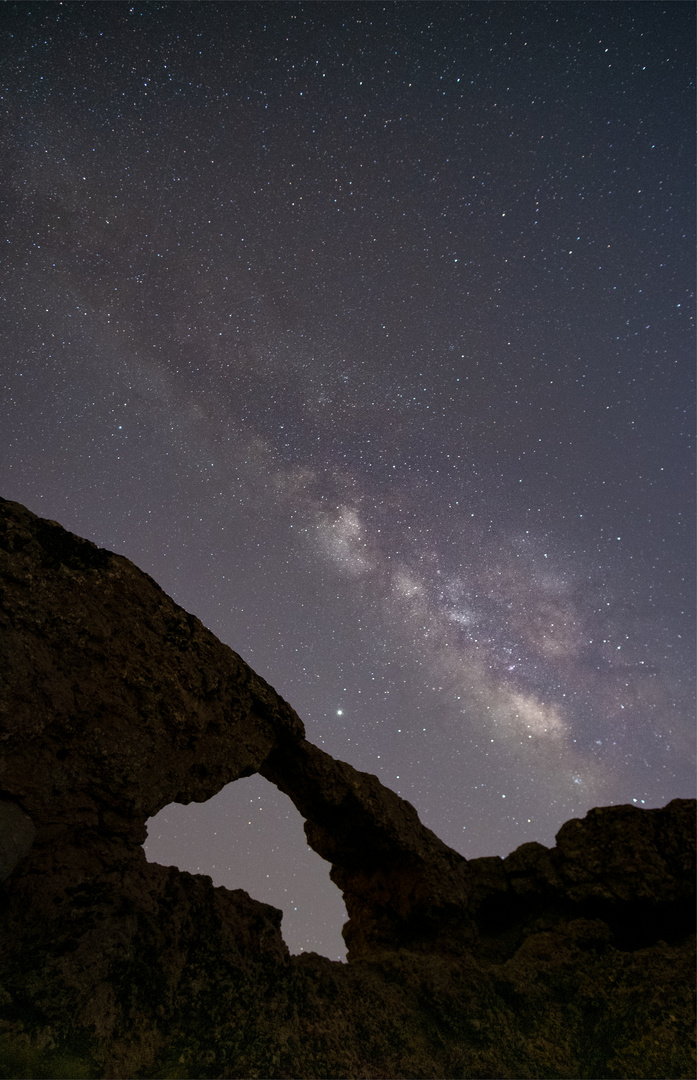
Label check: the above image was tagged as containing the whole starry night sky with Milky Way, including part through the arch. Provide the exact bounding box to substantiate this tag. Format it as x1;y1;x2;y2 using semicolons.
0;2;695;957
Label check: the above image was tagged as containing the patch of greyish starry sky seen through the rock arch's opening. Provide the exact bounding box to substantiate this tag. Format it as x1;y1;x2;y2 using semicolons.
143;773;348;961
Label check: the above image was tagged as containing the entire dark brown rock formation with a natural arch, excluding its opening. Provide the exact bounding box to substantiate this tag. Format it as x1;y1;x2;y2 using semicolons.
0;500;695;1078
